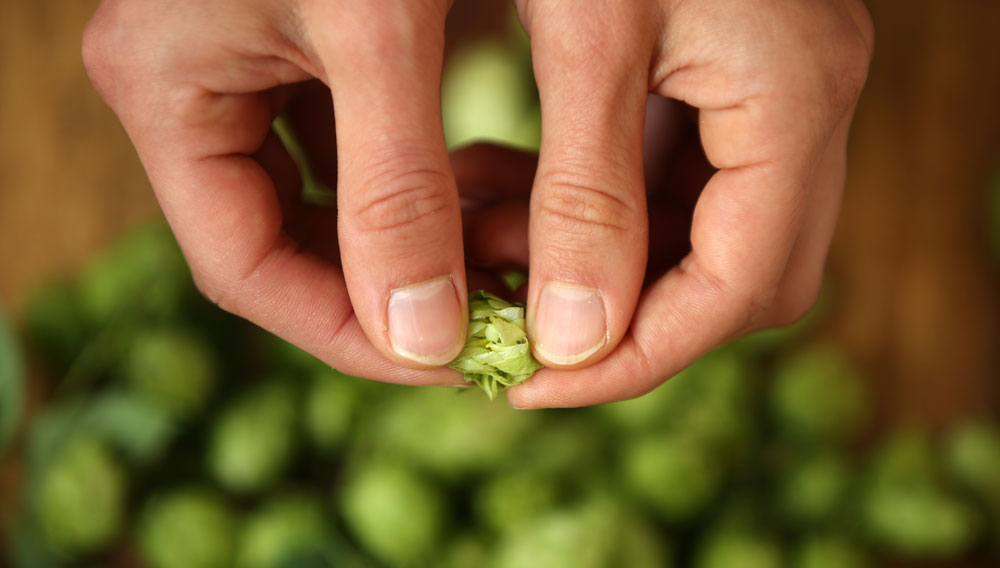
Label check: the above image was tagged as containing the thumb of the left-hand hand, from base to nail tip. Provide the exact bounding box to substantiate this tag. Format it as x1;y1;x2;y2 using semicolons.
309;0;468;368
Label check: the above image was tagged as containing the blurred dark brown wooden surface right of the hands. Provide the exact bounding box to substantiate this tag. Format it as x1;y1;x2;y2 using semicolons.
829;0;1000;425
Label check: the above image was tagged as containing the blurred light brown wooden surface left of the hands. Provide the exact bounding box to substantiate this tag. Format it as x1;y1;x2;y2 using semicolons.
0;0;157;312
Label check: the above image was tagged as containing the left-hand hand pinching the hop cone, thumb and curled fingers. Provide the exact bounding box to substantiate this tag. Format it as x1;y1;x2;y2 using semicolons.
83;0;488;384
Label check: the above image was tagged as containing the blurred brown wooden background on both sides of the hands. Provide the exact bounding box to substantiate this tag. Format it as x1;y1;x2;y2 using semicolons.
0;0;1000;424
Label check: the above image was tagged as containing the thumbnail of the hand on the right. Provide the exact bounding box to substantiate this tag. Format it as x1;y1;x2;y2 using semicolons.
532;282;608;365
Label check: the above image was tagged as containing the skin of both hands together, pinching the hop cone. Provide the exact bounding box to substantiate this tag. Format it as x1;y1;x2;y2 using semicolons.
83;0;873;408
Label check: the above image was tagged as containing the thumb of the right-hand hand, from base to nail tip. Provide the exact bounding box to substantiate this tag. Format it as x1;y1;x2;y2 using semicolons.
526;2;652;368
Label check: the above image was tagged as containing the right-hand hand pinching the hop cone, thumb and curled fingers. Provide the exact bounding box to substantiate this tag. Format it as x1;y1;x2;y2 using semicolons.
478;0;873;407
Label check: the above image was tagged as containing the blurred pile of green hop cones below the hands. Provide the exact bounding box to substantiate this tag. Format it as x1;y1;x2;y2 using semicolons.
5;219;1000;568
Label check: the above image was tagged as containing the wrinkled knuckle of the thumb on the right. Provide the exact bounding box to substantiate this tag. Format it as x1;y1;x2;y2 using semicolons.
538;172;641;238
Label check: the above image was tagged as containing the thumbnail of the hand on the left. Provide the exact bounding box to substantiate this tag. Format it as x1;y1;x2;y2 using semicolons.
387;276;465;365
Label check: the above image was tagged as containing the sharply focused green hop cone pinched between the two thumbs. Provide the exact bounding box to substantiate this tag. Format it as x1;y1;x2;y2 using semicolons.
449;290;542;400
